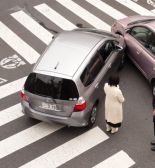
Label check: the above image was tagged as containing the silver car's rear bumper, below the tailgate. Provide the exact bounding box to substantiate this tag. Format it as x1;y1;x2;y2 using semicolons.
21;102;88;127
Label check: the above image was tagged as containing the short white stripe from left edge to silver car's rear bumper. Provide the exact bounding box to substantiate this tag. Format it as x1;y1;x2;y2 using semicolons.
0;103;24;126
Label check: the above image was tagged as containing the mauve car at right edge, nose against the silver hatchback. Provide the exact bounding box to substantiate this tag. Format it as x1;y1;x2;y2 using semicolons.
111;15;155;86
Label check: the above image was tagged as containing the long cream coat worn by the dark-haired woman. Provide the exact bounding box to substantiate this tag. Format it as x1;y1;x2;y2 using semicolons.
104;83;125;124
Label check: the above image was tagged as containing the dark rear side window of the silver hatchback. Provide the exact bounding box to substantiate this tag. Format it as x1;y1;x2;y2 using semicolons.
80;52;104;86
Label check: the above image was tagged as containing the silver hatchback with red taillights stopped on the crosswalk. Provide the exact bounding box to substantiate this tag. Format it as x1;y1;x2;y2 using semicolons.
20;28;124;127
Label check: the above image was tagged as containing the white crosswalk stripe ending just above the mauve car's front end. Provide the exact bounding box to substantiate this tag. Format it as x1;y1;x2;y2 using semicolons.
86;0;127;20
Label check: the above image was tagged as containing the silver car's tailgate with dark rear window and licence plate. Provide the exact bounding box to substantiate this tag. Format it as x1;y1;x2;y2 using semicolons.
24;73;79;117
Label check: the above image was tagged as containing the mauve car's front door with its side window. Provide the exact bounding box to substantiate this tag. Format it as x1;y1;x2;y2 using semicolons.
125;26;154;78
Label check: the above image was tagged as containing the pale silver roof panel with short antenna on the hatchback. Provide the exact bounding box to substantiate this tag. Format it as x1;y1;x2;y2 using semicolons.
34;31;104;77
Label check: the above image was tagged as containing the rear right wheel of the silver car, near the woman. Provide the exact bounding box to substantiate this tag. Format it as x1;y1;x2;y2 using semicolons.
88;104;98;127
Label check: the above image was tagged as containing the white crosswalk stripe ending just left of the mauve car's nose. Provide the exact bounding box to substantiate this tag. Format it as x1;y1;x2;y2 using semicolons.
56;0;111;31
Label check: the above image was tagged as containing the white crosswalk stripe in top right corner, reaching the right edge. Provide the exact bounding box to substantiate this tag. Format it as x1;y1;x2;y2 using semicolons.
115;0;155;16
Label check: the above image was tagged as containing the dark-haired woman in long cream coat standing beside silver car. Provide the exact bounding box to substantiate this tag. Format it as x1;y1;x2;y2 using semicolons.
104;74;124;133
